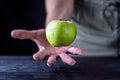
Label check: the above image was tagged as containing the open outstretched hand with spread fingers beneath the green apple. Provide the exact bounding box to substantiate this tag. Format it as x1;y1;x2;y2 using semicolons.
11;29;86;66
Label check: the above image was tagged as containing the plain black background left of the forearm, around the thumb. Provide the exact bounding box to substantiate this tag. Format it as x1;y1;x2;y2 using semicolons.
0;0;45;55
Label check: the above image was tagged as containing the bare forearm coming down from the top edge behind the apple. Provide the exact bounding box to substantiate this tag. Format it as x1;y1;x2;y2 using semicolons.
45;0;74;24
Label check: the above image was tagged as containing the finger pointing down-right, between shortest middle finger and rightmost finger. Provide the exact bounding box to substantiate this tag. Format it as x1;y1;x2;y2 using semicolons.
59;53;76;66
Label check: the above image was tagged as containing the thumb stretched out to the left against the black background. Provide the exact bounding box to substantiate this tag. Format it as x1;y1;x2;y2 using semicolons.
11;29;35;39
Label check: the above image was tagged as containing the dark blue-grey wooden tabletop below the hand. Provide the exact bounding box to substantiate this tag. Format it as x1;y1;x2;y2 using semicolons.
0;56;120;80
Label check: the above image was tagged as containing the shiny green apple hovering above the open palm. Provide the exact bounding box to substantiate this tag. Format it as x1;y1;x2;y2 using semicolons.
46;20;77;47
